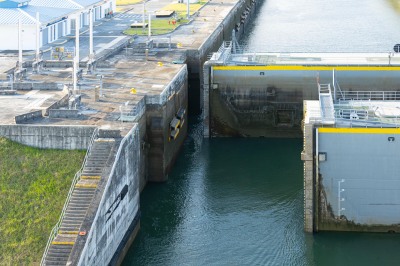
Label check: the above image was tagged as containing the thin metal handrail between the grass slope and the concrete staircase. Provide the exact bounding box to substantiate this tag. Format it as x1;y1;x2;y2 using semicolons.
40;128;99;266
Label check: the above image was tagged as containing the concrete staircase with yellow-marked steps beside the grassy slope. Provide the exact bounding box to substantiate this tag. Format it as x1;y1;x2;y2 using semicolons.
44;139;114;265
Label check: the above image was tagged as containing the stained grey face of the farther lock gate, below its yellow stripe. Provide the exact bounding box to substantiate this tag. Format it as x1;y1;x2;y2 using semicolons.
208;67;400;137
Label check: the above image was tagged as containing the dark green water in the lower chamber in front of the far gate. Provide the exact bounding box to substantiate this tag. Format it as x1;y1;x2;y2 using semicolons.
123;119;400;265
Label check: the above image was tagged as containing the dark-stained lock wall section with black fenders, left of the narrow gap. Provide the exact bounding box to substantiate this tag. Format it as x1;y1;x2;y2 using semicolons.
146;67;188;182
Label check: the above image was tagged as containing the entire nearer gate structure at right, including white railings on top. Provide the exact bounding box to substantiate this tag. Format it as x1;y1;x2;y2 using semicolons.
301;91;400;233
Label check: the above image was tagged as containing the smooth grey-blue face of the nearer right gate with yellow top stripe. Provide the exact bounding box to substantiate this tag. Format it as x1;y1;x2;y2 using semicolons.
316;128;400;232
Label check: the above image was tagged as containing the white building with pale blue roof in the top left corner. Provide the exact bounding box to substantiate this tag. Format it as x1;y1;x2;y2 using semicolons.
0;0;116;50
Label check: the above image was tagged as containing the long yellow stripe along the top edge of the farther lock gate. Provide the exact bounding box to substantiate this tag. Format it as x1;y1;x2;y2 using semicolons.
213;65;400;71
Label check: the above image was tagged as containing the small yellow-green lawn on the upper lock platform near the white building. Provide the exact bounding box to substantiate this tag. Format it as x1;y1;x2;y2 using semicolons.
124;1;207;35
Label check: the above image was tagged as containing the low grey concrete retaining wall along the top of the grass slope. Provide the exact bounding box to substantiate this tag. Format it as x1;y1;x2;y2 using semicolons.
0;125;95;150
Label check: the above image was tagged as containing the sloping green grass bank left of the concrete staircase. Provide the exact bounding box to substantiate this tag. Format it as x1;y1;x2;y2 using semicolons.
0;138;85;265
